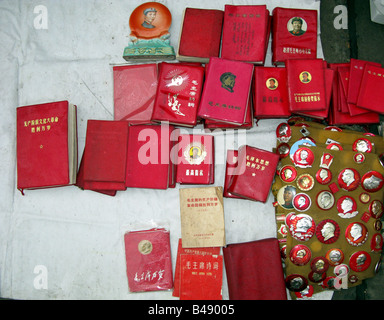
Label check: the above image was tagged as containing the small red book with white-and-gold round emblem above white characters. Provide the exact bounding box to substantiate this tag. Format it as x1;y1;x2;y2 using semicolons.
176;134;215;184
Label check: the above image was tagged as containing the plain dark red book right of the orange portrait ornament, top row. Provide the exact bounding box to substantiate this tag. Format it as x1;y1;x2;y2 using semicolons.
176;8;224;62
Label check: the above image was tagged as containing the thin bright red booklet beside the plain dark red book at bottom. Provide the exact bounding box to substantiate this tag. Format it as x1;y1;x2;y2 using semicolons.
180;254;223;300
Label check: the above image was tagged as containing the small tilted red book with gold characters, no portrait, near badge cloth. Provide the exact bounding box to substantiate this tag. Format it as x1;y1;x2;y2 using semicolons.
228;145;279;202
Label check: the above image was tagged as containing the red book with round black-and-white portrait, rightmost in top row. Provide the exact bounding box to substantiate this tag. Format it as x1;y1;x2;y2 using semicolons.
272;7;318;64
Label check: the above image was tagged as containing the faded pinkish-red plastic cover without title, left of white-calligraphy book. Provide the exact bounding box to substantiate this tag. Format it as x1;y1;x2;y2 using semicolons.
113;63;157;123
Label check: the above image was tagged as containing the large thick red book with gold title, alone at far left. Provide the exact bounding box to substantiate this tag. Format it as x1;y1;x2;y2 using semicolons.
16;101;77;193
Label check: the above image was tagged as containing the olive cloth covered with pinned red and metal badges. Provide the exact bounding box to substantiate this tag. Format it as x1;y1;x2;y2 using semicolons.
272;119;384;298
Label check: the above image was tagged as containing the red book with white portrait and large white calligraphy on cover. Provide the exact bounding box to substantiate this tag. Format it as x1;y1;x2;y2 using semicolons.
152;62;204;127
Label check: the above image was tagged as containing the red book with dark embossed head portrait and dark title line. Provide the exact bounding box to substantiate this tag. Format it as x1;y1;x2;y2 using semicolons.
198;58;253;125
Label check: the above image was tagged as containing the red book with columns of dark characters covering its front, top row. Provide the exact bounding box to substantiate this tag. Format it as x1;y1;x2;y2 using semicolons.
221;4;270;64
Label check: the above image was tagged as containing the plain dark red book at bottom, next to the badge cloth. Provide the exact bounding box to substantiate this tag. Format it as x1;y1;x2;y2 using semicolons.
223;238;287;300
